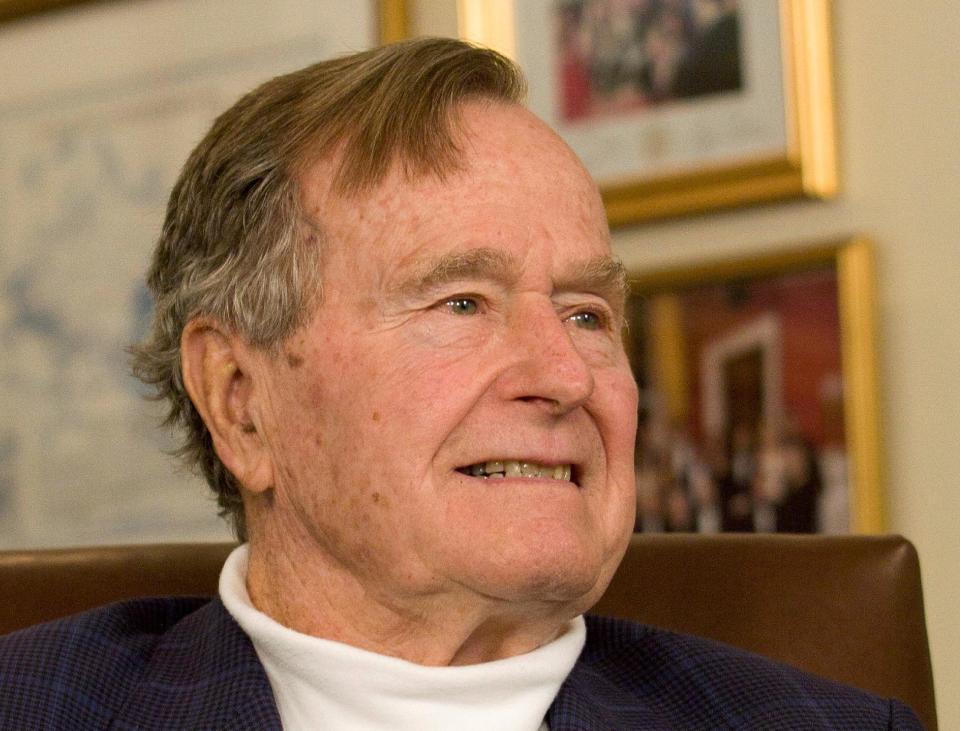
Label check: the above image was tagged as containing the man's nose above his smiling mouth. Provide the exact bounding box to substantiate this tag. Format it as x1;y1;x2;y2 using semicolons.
498;303;594;415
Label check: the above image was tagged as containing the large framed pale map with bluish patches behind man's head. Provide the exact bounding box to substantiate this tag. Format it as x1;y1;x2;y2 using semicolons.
0;0;404;549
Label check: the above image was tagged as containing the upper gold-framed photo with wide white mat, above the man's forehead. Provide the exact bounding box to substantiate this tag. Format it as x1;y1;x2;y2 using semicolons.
458;0;837;225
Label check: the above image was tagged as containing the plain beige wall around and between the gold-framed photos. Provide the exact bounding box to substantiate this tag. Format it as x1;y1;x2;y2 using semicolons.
419;0;960;729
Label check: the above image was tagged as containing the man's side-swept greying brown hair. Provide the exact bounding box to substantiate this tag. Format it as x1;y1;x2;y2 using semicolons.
130;38;525;540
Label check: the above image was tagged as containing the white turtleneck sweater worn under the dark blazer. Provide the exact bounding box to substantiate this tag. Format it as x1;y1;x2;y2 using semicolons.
220;545;586;731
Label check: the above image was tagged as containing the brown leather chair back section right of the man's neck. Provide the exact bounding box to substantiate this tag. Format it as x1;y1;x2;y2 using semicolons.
593;534;937;729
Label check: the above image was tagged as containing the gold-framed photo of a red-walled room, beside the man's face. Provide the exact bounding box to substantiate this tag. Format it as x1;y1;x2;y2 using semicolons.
626;238;884;533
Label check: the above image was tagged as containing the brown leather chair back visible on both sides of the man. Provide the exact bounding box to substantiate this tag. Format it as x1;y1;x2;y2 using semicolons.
0;535;936;729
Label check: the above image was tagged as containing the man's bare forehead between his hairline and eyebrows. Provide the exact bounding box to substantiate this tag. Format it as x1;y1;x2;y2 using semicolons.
302;102;609;282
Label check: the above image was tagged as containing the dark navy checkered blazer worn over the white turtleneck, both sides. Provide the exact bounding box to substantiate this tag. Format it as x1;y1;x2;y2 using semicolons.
0;598;921;731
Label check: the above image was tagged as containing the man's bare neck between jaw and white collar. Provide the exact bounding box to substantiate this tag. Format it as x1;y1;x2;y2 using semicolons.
247;535;576;666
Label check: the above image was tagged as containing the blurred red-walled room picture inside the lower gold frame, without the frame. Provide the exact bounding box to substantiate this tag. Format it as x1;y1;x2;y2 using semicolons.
629;260;851;533
